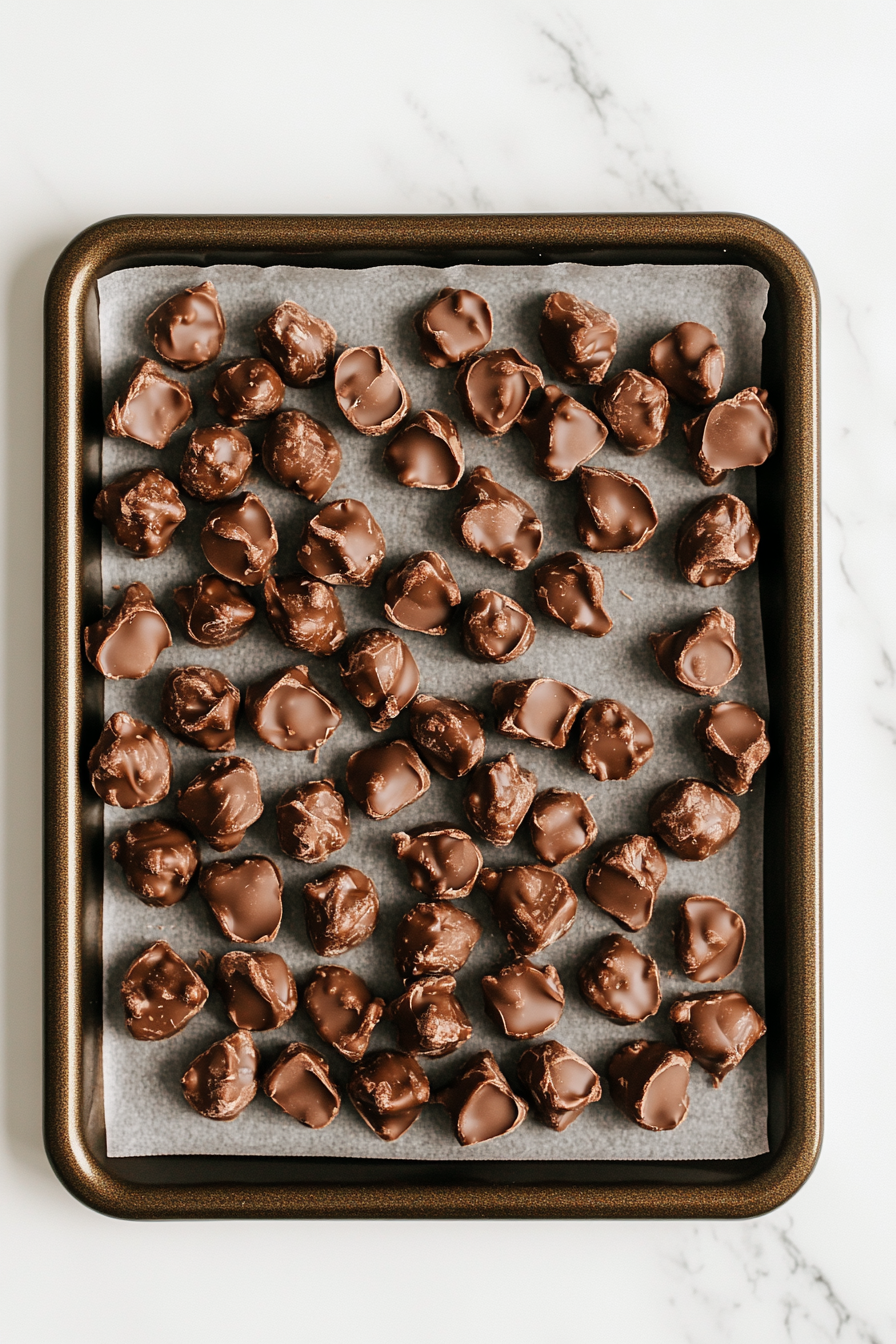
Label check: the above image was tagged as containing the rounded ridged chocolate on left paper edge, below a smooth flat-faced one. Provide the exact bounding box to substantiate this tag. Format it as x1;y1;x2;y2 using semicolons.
87;711;171;808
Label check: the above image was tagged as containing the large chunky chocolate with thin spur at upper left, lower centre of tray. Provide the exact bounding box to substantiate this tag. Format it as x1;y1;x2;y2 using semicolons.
480;863;579;957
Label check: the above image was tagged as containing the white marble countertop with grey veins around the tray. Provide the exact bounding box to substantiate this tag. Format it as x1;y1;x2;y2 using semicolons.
0;0;896;1344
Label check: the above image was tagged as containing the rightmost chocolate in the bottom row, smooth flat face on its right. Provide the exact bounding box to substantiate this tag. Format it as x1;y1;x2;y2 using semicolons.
607;1040;690;1133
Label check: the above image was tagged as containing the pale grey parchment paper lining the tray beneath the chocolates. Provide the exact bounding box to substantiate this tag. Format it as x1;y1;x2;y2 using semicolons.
98;263;774;1161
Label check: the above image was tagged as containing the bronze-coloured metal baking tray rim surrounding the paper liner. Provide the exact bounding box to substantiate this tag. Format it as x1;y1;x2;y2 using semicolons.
44;214;822;1218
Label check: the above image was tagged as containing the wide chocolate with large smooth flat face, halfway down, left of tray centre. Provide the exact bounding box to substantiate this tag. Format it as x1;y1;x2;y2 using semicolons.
244;667;343;751
